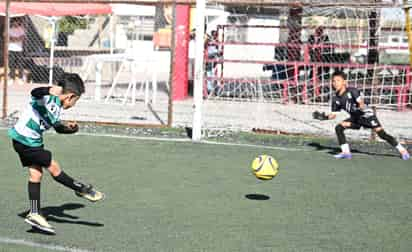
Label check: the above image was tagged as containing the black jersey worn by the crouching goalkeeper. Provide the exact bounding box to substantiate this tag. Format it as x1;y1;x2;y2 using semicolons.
332;87;364;117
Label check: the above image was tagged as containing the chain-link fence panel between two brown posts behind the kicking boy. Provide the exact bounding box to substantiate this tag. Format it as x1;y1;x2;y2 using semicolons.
0;2;173;126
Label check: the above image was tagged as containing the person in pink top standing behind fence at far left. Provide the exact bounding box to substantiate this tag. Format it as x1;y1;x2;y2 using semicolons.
9;18;26;85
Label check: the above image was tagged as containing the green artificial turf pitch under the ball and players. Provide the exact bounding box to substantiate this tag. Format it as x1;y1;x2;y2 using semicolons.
0;130;412;252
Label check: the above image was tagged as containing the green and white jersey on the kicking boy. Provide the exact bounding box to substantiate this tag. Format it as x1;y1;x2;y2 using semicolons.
8;95;62;147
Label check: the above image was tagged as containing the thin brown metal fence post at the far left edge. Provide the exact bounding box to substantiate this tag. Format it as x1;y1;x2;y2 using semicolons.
1;0;10;119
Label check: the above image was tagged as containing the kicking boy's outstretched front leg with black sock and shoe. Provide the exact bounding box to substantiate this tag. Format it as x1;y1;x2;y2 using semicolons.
47;160;104;202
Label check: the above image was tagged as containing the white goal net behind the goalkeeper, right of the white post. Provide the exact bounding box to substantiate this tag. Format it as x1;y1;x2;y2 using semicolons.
191;1;412;142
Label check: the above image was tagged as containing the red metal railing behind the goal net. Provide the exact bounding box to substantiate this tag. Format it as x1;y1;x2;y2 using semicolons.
205;31;412;111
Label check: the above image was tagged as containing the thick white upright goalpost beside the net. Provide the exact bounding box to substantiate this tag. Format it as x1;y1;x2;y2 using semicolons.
192;0;206;142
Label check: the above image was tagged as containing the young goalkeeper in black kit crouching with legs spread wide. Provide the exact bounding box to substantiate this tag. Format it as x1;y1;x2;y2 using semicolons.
313;71;410;160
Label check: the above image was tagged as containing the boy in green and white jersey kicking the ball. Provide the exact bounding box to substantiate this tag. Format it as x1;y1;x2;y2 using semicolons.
9;74;104;234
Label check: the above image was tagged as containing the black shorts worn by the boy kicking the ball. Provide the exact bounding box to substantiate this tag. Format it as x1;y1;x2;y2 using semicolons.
13;140;52;168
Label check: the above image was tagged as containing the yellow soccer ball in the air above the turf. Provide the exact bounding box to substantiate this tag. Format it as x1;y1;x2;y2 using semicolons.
252;155;279;180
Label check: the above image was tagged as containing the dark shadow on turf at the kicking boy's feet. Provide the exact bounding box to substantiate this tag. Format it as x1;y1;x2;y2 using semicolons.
18;203;104;234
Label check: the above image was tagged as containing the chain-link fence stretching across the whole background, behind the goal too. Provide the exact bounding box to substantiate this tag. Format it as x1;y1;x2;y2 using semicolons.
0;0;412;139
